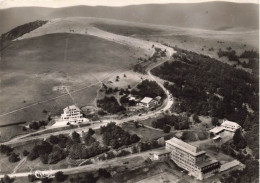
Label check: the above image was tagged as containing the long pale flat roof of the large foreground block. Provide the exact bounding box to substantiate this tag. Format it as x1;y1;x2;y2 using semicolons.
166;137;206;156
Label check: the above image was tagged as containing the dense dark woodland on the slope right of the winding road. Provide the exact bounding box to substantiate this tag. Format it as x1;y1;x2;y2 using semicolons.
152;48;259;161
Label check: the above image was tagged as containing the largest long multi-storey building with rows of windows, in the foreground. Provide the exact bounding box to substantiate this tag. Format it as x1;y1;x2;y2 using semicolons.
166;137;220;180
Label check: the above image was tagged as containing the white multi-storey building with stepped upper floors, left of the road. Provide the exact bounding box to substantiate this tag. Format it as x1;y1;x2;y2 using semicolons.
53;105;89;126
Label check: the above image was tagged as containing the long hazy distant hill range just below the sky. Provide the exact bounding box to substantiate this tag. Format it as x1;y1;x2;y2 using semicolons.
0;2;259;34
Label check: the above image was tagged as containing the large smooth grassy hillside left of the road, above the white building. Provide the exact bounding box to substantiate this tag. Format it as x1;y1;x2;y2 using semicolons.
0;34;144;125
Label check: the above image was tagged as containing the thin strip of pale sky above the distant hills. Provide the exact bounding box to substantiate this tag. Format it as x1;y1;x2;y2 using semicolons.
0;0;259;9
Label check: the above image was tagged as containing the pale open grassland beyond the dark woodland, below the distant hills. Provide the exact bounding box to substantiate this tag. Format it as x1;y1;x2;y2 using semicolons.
94;22;259;72
